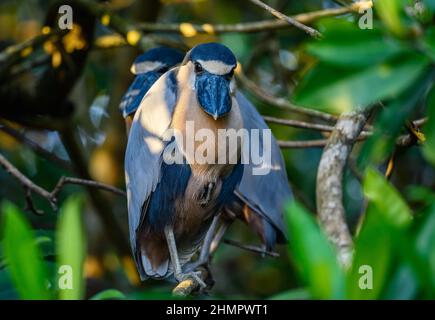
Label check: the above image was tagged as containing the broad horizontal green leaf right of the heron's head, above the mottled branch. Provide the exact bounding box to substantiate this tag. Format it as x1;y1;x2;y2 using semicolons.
294;54;429;114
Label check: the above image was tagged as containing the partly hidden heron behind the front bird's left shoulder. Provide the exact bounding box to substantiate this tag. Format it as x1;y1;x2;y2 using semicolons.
119;47;184;133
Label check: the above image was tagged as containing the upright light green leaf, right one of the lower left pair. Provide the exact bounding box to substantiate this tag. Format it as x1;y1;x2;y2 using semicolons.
56;196;86;300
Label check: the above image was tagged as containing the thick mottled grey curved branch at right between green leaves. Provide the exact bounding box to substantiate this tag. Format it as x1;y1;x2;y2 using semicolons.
316;112;366;268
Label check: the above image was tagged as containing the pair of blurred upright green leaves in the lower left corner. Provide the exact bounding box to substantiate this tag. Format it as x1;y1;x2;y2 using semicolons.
0;196;86;300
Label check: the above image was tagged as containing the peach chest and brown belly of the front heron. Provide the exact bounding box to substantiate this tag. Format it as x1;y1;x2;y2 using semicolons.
171;89;243;234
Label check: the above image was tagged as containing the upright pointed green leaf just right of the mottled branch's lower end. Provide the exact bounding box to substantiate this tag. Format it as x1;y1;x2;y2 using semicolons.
347;204;394;299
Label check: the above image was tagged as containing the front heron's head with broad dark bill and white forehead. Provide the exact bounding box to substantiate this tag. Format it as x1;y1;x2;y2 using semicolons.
183;42;237;120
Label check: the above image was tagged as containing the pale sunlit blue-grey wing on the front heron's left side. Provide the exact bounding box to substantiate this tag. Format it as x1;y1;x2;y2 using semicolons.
124;70;177;272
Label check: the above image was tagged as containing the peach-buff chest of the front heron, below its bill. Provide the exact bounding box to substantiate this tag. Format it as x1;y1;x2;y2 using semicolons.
171;90;243;178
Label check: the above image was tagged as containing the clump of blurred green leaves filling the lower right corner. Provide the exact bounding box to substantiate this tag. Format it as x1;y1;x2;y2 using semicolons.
286;169;435;299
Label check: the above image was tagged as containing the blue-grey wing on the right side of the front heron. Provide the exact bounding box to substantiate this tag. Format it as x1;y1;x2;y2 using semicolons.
235;92;292;241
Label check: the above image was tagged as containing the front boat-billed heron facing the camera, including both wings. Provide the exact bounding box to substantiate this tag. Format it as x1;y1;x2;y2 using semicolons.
125;43;292;282
